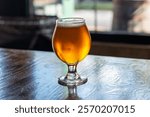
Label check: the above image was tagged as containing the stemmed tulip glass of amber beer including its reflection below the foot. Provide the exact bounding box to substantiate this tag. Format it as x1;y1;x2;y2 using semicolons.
52;18;91;99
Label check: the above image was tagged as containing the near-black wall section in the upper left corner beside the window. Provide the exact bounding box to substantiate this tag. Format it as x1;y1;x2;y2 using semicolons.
0;0;32;16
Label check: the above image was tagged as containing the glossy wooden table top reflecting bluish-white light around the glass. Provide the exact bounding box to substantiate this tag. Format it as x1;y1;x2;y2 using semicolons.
0;48;150;100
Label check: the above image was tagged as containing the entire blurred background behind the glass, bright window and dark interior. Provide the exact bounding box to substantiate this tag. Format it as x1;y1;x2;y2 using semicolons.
0;0;150;58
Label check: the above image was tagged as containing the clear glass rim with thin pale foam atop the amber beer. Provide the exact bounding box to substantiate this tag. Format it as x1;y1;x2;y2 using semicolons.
56;17;85;27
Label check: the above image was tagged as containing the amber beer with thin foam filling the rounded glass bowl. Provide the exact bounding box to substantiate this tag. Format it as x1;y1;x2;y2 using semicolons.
52;21;91;65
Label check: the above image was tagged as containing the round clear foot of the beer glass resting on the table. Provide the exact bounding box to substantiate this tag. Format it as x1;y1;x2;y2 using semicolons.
58;76;88;86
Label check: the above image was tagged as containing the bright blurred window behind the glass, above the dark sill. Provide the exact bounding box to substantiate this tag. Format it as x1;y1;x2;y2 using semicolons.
34;0;150;33
